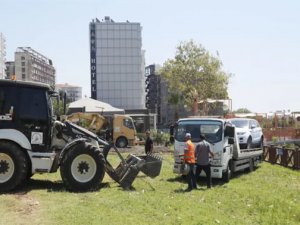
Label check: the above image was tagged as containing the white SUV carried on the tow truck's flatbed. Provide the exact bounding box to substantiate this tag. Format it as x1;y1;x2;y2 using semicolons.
229;118;264;149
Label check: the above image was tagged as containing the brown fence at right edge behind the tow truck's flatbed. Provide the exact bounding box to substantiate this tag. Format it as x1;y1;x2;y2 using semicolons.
263;145;300;170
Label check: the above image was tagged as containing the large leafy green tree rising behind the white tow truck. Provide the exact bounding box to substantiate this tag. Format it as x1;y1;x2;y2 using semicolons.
160;40;231;117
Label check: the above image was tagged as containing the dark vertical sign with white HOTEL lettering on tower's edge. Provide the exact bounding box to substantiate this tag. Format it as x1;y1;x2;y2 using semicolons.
90;22;97;99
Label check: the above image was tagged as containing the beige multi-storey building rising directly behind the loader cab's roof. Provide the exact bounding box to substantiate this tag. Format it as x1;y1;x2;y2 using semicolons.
15;47;55;86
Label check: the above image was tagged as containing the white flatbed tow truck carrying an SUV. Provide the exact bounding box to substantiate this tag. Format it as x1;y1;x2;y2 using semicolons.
170;117;263;182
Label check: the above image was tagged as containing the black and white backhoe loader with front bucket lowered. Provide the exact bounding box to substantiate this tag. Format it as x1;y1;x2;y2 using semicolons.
0;80;162;192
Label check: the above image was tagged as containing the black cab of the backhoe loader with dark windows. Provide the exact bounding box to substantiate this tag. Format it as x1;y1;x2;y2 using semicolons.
0;80;54;152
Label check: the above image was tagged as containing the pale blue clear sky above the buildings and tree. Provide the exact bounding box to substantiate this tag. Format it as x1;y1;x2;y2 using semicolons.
0;0;300;112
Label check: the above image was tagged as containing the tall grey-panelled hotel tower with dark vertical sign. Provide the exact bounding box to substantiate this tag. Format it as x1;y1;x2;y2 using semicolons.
90;17;145;109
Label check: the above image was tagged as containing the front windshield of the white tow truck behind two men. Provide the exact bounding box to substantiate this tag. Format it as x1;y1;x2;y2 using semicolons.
175;120;223;143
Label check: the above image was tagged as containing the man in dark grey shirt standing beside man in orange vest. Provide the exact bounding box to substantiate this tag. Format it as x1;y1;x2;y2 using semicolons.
195;134;214;188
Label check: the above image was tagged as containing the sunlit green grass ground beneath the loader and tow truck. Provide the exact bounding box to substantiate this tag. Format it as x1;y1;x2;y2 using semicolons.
0;153;300;225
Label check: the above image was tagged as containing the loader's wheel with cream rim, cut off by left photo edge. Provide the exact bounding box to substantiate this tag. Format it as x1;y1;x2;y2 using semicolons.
0;142;28;192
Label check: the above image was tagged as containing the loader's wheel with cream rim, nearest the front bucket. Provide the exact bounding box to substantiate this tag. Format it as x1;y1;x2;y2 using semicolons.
60;142;105;192
